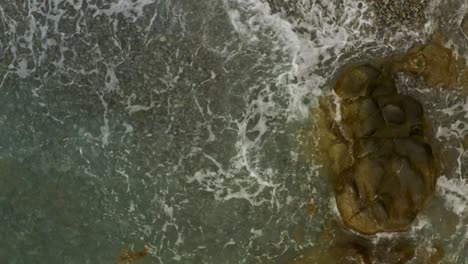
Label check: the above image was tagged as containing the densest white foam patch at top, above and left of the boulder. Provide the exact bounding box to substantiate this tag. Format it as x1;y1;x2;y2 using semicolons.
226;0;432;120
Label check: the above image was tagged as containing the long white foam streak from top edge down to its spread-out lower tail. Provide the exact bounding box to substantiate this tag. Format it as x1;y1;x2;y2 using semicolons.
189;0;438;209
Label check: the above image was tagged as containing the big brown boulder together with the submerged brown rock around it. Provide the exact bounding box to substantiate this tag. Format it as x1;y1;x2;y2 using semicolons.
294;33;468;264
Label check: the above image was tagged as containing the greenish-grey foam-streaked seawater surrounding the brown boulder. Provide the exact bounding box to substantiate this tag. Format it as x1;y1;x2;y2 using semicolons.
0;0;468;264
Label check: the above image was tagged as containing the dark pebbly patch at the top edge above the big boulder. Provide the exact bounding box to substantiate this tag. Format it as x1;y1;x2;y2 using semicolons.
367;0;428;28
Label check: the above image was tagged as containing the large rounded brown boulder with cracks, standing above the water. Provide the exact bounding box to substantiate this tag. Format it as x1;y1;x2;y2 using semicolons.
322;64;436;234
